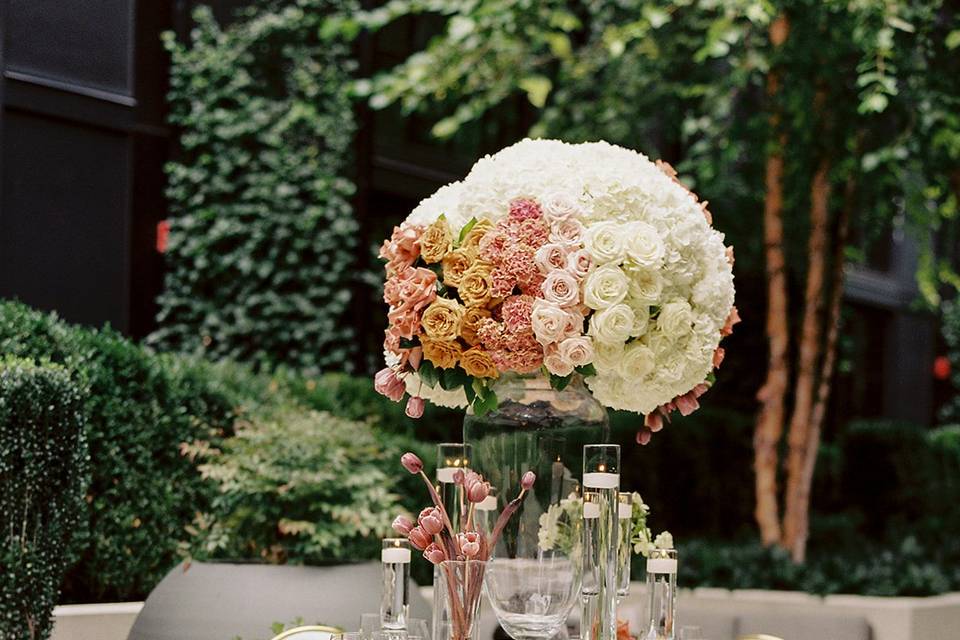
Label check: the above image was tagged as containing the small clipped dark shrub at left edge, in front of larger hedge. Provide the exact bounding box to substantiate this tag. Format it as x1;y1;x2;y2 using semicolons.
0;356;89;640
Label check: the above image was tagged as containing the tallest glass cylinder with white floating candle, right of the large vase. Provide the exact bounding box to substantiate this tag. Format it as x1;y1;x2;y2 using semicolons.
581;444;620;640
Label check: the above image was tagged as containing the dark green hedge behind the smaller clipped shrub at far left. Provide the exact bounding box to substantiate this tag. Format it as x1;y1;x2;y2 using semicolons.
0;302;234;601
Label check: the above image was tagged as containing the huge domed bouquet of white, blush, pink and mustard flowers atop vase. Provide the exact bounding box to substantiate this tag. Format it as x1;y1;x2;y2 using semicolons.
375;140;739;442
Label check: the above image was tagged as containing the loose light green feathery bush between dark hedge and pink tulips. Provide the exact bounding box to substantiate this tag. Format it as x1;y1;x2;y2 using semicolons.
192;409;402;563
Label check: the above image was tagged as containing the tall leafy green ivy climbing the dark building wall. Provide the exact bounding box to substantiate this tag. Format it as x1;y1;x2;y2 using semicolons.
150;0;358;373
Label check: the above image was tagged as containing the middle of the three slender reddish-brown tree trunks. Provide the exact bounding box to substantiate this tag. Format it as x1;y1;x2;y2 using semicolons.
783;157;830;562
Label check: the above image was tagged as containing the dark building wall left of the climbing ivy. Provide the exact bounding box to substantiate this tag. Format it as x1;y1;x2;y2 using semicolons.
0;0;171;335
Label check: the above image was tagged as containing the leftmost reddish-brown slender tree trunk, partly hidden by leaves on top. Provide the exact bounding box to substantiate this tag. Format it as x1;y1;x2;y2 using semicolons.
753;15;790;546
